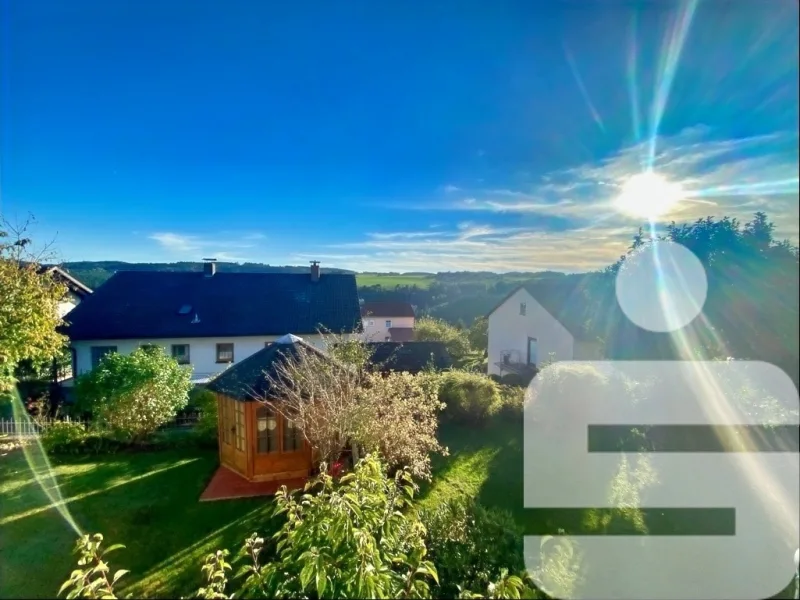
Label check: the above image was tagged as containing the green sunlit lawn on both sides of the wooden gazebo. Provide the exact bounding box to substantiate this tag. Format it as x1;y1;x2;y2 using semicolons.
0;421;791;598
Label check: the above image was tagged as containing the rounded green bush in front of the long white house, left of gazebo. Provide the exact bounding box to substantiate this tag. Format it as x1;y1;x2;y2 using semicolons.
75;348;192;440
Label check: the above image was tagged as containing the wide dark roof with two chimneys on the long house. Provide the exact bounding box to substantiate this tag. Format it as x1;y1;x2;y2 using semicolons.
66;271;361;340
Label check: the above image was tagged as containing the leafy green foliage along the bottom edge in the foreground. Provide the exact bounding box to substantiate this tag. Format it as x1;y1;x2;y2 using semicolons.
61;455;532;598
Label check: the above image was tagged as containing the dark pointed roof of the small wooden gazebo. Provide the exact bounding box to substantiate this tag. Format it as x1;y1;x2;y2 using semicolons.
206;336;324;401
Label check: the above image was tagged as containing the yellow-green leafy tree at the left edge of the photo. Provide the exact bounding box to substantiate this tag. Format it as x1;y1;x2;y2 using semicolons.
0;222;67;394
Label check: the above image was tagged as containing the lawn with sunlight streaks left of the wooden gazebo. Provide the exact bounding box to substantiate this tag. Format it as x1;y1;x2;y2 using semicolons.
0;449;282;598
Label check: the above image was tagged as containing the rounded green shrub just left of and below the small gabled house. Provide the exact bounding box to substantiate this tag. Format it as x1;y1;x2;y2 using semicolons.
439;371;501;425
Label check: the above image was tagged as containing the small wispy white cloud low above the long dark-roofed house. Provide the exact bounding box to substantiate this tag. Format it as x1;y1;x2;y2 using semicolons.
148;232;265;262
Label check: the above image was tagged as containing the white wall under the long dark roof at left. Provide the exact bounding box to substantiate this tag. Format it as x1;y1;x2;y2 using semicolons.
71;334;324;378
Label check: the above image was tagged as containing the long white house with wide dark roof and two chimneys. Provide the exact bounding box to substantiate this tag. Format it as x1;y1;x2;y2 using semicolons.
67;261;361;383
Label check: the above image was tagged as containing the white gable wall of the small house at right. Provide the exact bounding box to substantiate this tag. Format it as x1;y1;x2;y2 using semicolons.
489;289;574;375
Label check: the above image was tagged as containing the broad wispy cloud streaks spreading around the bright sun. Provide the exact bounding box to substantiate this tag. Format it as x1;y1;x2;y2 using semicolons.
304;127;799;272
